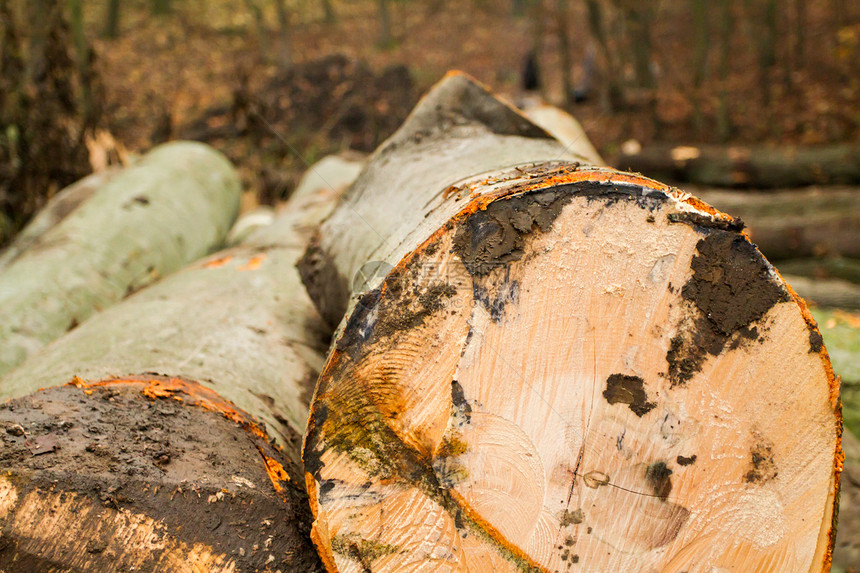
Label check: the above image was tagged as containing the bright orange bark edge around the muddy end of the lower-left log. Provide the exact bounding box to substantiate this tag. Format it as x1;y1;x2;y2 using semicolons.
67;375;292;498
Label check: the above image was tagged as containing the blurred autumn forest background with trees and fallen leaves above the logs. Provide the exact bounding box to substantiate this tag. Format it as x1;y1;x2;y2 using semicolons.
0;0;860;237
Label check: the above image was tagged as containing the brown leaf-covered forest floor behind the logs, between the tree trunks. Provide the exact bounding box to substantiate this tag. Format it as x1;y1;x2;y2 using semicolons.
87;0;860;202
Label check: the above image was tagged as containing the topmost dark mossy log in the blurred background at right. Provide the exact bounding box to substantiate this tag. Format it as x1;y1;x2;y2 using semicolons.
617;144;860;189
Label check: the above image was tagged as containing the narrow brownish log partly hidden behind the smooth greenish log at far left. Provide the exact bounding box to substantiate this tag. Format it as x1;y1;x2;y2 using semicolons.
0;169;119;269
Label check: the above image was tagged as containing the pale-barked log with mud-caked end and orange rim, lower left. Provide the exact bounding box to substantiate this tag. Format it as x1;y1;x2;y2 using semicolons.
0;154;364;572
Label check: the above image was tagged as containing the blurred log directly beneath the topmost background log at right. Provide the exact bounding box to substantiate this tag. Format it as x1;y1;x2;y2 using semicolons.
694;188;860;260
